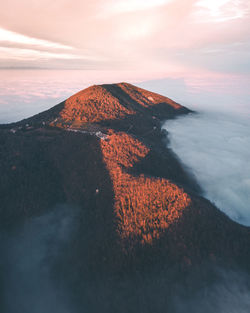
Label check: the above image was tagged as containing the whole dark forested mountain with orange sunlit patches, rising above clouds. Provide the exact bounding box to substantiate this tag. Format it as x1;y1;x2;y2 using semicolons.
0;83;250;312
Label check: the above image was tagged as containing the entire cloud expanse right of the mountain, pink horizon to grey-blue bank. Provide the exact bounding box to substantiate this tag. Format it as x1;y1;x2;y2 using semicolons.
141;79;250;226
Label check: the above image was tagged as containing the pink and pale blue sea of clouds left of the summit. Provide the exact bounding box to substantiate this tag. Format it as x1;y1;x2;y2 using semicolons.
0;69;149;124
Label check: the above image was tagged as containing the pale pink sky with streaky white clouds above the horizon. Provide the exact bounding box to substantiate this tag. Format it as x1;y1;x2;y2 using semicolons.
0;0;250;75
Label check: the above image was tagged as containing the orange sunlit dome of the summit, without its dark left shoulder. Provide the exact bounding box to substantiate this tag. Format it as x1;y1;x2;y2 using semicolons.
59;82;188;123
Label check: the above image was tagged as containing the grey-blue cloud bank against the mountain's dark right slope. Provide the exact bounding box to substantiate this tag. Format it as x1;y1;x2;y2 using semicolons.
164;112;250;226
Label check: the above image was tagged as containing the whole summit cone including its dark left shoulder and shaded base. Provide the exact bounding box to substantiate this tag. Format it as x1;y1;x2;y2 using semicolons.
7;82;188;128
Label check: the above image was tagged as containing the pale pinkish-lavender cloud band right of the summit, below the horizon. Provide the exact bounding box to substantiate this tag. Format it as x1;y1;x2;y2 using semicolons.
139;74;250;116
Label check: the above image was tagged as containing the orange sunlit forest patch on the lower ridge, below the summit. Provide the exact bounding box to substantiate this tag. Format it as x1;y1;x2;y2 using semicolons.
101;133;190;245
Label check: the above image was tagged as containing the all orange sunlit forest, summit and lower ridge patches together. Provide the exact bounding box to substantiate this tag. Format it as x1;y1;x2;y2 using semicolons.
52;83;191;247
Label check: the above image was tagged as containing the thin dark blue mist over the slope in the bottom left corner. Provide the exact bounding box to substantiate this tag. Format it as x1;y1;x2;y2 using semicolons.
0;206;76;313
